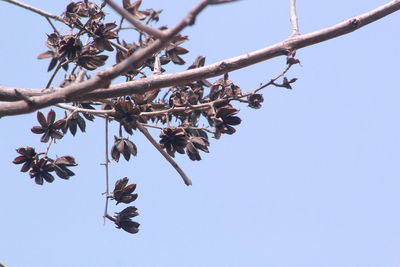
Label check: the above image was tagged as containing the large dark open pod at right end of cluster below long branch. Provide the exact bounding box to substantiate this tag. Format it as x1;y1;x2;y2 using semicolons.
213;105;241;134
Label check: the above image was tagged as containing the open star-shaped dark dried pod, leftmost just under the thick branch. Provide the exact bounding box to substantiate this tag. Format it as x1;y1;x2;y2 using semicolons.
31;109;63;143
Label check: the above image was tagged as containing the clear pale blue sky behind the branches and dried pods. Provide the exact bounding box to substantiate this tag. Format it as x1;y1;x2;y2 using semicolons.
0;0;400;267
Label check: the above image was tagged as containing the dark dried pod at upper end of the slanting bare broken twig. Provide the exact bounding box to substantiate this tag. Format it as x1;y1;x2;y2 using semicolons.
113;100;142;134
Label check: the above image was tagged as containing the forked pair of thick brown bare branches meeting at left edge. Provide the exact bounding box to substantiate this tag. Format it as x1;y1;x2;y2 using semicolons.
0;0;400;116
